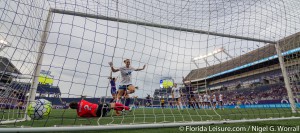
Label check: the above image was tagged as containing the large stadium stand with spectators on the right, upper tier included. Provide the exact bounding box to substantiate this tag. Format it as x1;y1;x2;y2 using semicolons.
170;33;300;109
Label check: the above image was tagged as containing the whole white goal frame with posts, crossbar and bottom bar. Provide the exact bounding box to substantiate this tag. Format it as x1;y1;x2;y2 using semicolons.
0;5;300;132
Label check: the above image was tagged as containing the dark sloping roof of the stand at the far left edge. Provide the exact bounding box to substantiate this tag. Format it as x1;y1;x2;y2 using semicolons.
0;56;22;76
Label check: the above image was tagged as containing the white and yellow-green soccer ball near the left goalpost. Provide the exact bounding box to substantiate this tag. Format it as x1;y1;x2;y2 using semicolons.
27;99;52;119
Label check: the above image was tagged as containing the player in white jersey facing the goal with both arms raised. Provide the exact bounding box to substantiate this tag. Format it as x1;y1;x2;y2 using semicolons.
108;59;146;106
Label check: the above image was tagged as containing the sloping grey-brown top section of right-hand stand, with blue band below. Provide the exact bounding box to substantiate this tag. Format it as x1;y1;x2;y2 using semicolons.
185;32;300;81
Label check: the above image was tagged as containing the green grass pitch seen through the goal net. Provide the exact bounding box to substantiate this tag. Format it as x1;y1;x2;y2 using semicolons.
1;108;300;133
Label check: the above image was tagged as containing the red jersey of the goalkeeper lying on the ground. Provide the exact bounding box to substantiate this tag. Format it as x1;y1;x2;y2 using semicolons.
77;100;98;117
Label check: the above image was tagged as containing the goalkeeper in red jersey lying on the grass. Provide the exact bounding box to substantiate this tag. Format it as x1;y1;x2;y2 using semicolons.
69;99;131;117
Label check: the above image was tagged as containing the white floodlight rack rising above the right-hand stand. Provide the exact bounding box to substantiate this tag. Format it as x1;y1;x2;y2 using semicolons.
192;47;233;68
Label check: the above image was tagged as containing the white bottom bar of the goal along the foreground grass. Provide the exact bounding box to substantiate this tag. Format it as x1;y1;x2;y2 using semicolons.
0;117;300;133
